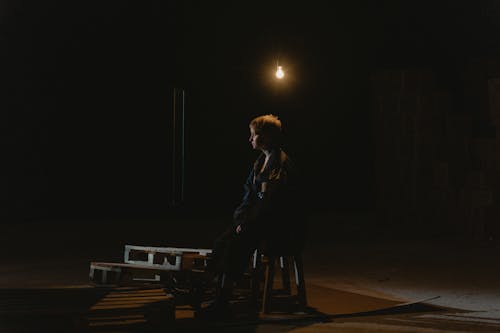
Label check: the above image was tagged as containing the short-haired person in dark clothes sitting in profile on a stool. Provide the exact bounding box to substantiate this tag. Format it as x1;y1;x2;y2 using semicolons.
197;114;303;319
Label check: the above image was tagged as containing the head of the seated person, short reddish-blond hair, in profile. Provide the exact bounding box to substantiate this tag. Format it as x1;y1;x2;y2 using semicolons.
249;114;281;150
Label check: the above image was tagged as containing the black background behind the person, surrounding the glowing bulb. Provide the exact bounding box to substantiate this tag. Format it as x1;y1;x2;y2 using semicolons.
0;0;500;227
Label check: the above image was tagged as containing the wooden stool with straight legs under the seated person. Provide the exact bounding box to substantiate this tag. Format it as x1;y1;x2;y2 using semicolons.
252;249;307;313
